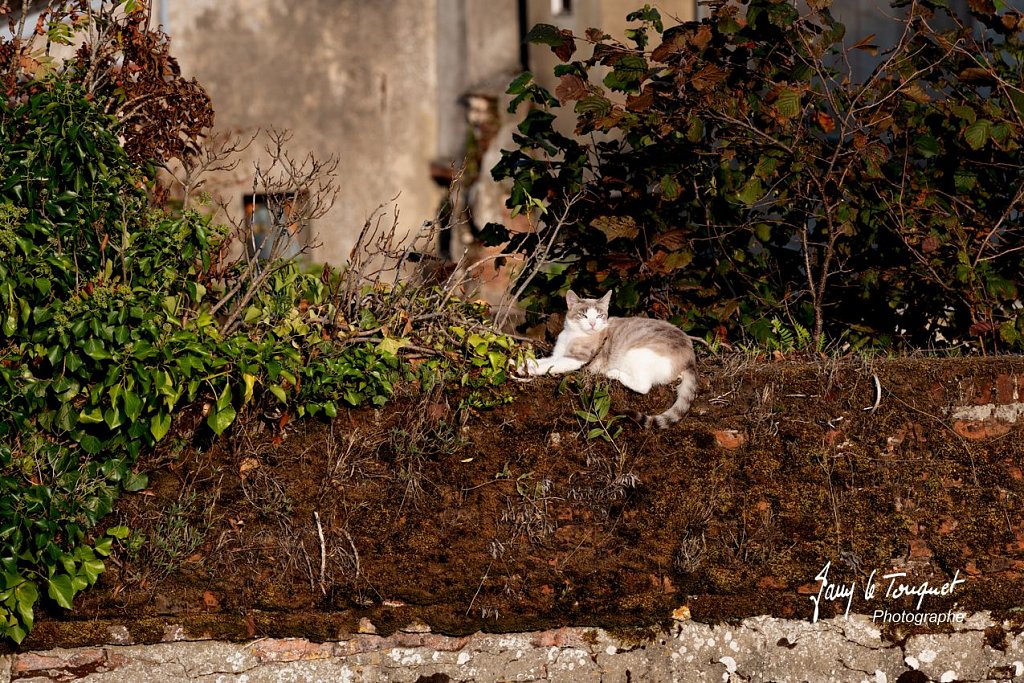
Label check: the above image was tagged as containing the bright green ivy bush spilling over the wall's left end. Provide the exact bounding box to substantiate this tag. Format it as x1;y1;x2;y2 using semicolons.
0;3;515;642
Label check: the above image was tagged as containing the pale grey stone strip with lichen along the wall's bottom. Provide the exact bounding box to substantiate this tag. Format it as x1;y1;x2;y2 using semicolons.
0;613;1024;683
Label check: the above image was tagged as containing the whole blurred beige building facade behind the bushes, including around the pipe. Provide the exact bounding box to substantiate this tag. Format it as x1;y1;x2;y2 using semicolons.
154;0;696;264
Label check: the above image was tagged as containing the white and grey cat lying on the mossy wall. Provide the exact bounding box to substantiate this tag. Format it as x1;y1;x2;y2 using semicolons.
523;290;697;428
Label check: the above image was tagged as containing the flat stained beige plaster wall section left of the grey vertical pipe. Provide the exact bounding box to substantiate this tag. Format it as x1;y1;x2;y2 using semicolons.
168;0;438;261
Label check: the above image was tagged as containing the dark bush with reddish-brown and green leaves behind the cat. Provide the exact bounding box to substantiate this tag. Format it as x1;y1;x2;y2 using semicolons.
485;0;1024;349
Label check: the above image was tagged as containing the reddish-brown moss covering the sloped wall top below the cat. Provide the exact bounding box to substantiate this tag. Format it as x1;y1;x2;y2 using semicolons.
9;358;1024;645
